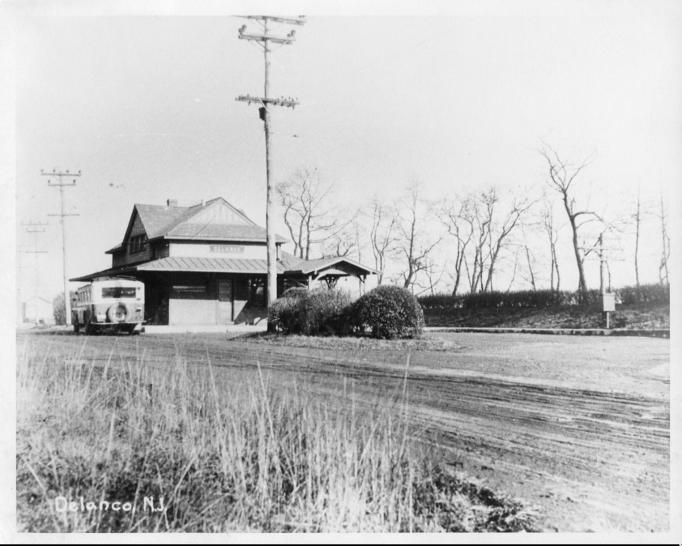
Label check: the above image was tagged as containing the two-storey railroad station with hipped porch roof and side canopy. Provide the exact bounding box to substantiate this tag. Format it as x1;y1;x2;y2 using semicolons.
71;197;374;325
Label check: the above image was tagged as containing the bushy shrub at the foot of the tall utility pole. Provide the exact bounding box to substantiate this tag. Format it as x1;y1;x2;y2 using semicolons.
268;288;350;335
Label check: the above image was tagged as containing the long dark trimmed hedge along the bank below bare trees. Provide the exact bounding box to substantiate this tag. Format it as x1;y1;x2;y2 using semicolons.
419;284;670;311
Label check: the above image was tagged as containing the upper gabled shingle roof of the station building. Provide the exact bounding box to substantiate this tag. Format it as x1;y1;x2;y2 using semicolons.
107;197;287;254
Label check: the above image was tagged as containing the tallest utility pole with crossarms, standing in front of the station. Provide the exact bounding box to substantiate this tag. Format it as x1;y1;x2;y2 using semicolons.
236;15;305;328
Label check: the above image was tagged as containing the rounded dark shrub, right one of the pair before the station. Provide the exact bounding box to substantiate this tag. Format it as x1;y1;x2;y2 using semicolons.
349;285;424;339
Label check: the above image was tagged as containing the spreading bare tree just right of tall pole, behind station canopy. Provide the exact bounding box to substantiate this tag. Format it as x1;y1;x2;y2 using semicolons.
276;168;348;260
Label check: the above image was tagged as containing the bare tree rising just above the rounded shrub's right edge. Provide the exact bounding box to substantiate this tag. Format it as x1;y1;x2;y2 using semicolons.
395;183;440;288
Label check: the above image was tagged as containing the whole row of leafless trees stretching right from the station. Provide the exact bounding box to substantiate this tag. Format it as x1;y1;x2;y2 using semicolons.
277;145;670;295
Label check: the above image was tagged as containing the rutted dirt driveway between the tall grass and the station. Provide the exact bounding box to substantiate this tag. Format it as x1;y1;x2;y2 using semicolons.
17;333;670;531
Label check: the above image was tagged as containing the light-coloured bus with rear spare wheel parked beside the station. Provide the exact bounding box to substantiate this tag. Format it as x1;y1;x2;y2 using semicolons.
71;277;144;334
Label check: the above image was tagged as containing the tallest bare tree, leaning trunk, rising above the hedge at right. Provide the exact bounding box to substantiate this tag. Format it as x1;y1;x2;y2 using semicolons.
540;146;601;299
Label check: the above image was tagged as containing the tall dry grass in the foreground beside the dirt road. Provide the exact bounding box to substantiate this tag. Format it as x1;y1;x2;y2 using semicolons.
17;338;535;532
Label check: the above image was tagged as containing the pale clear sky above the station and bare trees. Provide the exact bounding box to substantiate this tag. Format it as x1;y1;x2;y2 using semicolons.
14;2;682;299
